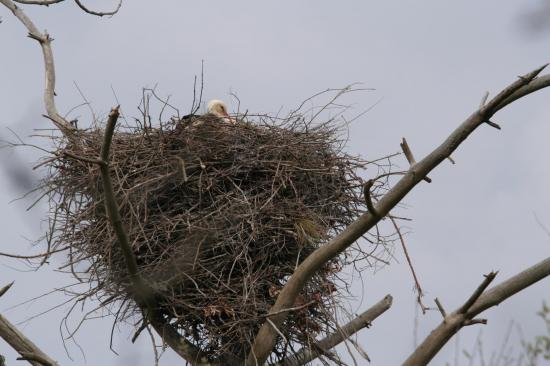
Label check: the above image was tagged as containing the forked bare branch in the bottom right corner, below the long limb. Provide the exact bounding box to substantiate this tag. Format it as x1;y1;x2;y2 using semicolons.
403;257;550;366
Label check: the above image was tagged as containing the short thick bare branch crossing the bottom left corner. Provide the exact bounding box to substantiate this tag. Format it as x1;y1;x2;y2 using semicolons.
0;282;58;366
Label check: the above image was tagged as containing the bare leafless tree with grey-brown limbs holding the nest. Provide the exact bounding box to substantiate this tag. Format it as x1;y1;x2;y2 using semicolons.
0;0;550;366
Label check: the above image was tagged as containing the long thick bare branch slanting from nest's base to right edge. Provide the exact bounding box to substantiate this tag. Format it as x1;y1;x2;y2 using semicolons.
246;67;550;366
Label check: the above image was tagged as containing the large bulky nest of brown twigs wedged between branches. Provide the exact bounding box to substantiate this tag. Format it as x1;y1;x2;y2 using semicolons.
45;109;382;361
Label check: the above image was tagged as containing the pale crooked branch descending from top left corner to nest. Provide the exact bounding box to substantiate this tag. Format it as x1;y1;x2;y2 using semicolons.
0;0;74;135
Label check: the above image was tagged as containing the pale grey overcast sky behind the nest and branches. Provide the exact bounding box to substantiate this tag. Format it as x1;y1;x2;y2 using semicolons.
0;0;550;365
